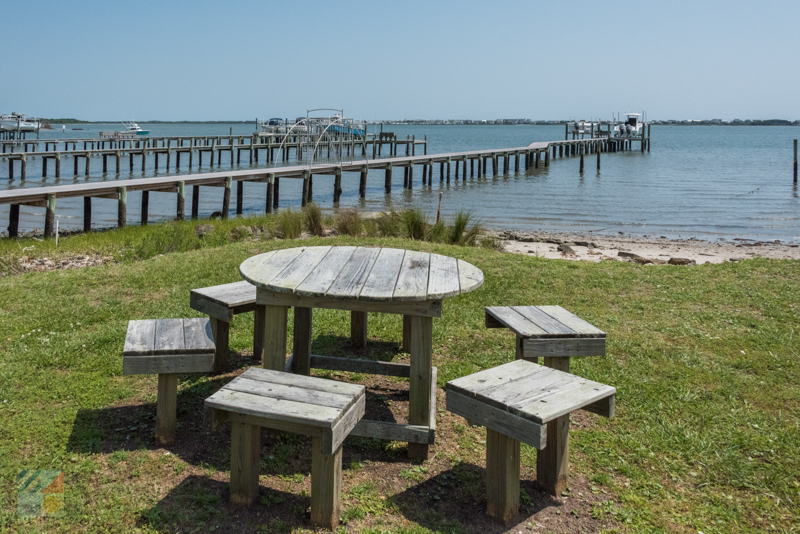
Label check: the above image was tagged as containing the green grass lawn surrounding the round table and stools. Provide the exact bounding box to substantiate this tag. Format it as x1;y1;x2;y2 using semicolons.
0;230;800;534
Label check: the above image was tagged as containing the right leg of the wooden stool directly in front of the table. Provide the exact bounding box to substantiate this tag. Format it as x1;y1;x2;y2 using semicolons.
311;437;342;530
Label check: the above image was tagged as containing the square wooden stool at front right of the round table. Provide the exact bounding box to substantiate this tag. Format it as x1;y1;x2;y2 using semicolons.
446;360;616;524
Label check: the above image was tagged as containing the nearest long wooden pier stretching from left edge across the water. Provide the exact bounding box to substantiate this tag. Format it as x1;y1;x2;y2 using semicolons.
0;137;650;238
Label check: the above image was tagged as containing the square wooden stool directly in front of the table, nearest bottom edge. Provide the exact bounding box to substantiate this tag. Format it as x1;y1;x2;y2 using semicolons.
205;367;366;530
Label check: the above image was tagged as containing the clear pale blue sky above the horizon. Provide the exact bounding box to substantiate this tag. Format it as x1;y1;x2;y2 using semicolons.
6;0;800;120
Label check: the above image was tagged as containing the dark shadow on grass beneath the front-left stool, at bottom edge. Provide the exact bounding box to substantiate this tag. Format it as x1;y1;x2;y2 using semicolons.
137;475;311;533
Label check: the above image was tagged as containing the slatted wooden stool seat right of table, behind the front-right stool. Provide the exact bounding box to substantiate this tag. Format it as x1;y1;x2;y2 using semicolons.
485;306;606;371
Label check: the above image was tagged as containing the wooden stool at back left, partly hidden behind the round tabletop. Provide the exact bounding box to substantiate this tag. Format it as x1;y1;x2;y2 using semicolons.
189;281;264;374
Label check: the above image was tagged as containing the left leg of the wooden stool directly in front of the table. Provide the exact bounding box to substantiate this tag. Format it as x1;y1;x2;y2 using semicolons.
231;421;261;506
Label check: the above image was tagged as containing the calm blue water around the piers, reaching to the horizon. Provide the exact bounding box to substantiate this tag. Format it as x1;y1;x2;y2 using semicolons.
0;124;800;241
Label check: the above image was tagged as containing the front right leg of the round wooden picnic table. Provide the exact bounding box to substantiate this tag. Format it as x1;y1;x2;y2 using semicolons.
404;315;433;460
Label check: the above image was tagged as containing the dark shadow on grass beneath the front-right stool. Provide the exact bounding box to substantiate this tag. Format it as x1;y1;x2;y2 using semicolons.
390;464;561;534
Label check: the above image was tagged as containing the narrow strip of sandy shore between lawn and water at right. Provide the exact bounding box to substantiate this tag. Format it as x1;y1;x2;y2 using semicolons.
492;230;800;264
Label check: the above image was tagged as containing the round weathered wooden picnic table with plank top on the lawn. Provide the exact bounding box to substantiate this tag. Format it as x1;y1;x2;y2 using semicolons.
239;246;483;458
